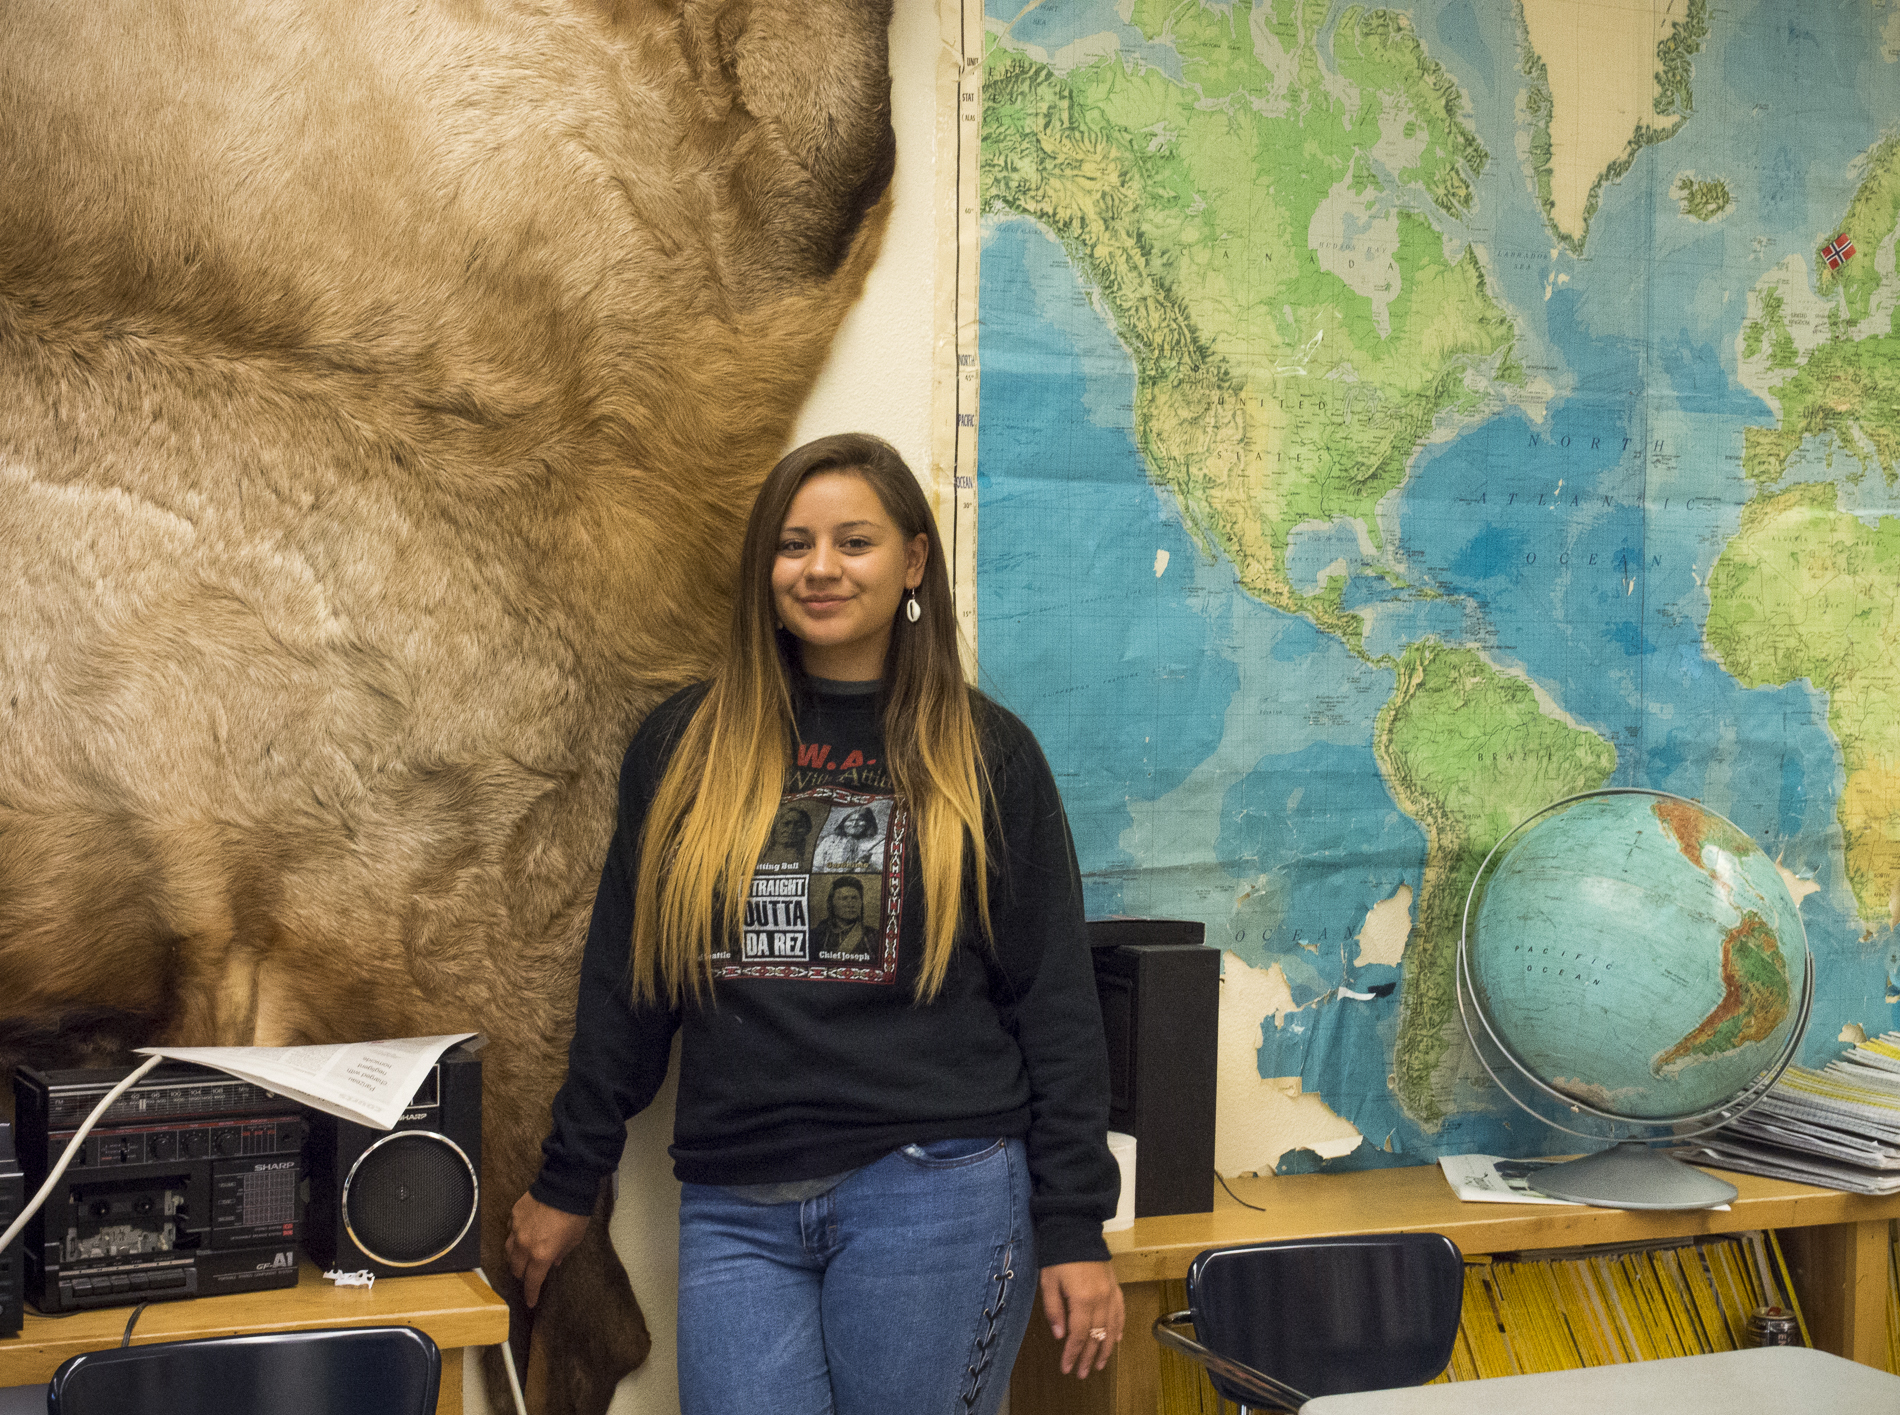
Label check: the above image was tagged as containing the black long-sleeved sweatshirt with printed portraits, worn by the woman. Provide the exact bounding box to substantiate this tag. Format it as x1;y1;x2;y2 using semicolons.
532;686;1119;1267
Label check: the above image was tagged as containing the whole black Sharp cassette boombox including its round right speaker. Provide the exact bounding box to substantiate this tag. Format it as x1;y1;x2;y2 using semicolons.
11;1047;481;1331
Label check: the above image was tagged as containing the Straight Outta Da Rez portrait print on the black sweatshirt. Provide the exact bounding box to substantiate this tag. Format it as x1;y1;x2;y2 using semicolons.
714;773;910;984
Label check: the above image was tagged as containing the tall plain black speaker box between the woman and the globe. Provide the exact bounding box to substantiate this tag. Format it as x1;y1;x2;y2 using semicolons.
1089;919;1220;1217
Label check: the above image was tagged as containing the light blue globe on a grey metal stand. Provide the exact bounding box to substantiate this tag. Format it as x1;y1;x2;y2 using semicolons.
1457;790;1813;1208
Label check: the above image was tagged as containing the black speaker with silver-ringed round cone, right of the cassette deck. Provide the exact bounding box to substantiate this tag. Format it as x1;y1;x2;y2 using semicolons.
304;1045;481;1278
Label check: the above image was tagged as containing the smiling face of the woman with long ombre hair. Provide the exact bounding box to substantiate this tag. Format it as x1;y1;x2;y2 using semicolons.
771;471;929;682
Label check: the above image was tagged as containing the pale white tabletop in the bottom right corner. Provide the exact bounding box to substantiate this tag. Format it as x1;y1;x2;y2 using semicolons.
1302;1347;1900;1415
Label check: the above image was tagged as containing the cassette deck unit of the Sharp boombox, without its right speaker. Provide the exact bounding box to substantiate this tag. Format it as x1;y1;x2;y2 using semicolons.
13;1062;304;1312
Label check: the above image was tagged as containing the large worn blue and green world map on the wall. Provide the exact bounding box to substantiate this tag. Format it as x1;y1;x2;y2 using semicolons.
977;0;1900;1174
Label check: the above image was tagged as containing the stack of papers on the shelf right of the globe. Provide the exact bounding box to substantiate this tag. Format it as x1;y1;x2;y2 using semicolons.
1695;1031;1900;1195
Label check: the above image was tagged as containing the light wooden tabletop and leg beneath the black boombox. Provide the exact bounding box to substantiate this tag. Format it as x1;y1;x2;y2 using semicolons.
0;1259;507;1415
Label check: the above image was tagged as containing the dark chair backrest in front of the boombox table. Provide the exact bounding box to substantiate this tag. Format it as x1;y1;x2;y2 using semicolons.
46;1326;438;1415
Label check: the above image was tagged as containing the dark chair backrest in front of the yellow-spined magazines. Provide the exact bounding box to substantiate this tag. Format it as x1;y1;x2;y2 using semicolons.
1188;1233;1465;1406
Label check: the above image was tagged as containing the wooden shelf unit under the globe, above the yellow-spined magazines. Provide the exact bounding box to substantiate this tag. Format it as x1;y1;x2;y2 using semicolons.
1011;1164;1900;1415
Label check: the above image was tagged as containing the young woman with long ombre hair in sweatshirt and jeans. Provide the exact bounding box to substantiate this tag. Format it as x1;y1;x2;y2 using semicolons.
507;435;1123;1415
